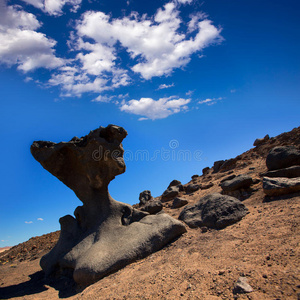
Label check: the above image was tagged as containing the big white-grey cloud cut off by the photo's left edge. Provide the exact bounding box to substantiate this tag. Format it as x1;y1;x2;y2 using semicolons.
0;0;64;72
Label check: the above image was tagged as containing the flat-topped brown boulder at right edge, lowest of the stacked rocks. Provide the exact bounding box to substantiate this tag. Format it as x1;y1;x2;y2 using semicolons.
263;177;300;196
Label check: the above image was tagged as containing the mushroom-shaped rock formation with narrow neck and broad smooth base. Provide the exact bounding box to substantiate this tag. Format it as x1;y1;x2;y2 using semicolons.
31;125;186;285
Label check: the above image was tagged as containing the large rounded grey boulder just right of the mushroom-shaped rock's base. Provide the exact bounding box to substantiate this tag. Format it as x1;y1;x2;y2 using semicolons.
179;193;248;229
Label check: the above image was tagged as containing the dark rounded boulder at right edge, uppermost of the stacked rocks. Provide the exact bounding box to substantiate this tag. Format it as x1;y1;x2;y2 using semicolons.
266;146;300;171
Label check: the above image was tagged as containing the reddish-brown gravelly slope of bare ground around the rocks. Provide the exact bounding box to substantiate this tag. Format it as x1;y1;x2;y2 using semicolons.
0;128;300;300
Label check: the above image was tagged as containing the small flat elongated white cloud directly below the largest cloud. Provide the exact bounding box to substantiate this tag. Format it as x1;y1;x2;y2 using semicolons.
120;96;191;121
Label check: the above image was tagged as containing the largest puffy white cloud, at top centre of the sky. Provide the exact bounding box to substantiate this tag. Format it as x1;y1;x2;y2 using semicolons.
76;2;222;79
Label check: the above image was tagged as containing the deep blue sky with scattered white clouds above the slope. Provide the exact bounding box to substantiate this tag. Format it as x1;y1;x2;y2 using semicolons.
0;0;300;247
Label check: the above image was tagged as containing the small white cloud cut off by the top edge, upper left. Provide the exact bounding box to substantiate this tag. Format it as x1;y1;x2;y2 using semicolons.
23;0;81;16
